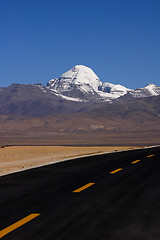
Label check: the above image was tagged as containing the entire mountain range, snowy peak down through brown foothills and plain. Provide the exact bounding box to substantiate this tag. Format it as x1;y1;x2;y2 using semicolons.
0;65;160;145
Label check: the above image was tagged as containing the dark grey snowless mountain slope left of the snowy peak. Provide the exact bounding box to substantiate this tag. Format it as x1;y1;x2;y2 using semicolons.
0;84;95;117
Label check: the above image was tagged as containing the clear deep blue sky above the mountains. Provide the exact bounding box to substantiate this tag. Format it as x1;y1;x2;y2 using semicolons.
0;0;160;89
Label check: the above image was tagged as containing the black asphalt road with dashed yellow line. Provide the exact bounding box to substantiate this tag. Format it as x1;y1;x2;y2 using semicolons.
0;147;160;240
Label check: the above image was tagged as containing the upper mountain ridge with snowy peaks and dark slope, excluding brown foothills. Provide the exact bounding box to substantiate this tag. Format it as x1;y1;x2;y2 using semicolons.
0;65;160;117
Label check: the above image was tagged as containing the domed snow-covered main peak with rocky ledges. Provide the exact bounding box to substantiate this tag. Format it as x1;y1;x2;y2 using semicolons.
47;65;131;102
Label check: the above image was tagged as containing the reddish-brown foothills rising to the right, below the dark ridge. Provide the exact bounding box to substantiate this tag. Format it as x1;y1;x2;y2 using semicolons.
0;96;160;134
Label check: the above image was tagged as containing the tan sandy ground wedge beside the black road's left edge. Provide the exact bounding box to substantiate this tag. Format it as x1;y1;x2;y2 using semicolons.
0;146;137;175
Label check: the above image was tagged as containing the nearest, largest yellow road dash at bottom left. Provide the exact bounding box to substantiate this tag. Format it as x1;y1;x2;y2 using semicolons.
0;213;40;238
